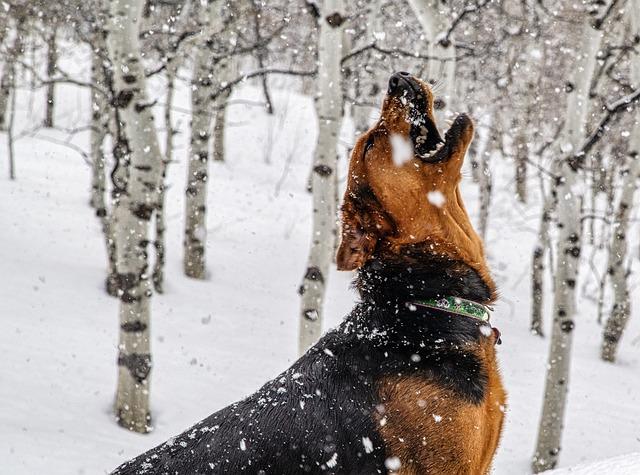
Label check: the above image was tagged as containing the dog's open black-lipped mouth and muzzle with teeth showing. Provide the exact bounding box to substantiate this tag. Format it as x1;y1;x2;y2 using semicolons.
387;71;471;163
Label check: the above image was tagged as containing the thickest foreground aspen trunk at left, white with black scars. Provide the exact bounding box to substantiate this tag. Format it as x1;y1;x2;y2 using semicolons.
107;0;162;432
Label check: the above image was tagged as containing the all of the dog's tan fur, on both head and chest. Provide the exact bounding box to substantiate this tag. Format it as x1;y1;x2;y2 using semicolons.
337;74;506;475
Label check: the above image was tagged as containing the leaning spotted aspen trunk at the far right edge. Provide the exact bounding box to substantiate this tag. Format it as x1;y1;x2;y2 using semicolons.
601;1;640;362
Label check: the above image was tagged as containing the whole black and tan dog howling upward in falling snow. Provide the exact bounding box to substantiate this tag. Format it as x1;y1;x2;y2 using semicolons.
115;72;505;475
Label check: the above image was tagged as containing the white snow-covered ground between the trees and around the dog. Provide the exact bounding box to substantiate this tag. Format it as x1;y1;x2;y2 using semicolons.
0;50;640;475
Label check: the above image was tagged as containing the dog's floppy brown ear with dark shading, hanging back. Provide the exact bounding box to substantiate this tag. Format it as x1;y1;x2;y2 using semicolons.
336;189;394;270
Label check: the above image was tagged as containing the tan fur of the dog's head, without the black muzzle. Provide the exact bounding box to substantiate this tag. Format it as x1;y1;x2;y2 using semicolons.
337;77;495;300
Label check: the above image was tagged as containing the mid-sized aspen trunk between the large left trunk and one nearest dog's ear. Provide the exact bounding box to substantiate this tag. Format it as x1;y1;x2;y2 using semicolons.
183;0;226;279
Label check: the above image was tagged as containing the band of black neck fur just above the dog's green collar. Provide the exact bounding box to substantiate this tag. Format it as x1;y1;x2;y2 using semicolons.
355;246;492;307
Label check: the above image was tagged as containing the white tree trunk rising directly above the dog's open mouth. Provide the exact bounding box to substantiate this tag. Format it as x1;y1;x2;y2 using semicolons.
409;0;456;127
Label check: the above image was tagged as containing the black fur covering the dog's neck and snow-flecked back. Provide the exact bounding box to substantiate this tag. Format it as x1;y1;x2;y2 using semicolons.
114;252;488;475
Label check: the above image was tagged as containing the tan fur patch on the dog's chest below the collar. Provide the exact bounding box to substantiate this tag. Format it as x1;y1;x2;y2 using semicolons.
374;338;506;475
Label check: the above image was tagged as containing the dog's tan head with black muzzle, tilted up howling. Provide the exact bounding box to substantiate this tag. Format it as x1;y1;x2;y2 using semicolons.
337;72;495;291
